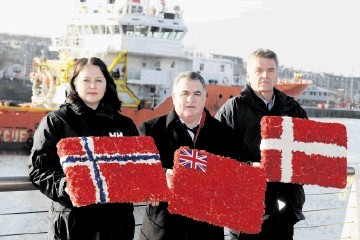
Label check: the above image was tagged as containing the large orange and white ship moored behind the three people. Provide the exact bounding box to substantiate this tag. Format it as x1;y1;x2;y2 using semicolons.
0;0;311;149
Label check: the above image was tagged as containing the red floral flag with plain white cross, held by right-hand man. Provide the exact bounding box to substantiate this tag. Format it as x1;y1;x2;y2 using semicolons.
260;116;347;188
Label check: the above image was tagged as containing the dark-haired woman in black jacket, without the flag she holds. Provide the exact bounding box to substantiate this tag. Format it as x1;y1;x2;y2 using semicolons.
29;57;138;240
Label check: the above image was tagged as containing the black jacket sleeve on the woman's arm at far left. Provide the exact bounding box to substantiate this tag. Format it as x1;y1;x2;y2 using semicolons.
29;113;72;207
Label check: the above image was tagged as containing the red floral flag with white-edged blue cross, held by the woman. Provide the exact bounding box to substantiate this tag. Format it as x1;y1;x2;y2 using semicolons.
57;136;170;206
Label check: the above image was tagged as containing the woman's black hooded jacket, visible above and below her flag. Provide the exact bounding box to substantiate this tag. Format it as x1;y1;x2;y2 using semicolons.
29;103;138;239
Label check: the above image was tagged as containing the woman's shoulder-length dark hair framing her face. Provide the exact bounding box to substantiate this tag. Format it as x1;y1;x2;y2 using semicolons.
66;57;121;111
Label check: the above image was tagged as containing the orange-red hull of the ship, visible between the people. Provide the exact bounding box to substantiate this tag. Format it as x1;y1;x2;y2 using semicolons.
0;83;308;150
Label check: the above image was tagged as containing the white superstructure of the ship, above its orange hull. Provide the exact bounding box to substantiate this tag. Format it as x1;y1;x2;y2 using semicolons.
50;0;239;107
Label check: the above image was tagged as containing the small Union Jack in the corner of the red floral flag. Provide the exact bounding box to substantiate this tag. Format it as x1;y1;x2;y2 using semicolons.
179;149;207;172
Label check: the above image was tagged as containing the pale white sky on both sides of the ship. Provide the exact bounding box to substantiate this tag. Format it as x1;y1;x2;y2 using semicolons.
0;0;360;76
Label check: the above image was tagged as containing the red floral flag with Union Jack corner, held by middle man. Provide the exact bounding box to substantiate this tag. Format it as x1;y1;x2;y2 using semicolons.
168;147;266;233
